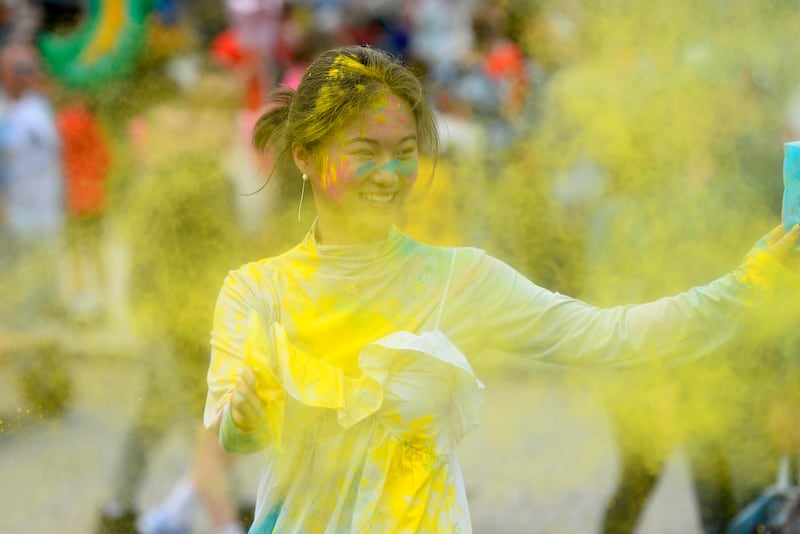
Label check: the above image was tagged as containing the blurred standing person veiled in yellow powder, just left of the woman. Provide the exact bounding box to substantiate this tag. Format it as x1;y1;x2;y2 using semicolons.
97;75;253;534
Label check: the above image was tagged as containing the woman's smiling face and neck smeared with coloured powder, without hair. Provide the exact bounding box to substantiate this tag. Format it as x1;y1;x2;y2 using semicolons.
306;92;419;243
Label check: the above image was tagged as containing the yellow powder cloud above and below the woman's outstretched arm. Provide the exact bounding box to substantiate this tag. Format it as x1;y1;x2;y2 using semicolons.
462;2;800;531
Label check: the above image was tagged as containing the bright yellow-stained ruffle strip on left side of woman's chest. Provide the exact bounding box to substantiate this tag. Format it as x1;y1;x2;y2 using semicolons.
243;312;383;449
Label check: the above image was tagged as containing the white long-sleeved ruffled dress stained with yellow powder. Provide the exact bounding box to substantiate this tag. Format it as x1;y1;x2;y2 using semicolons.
205;224;784;534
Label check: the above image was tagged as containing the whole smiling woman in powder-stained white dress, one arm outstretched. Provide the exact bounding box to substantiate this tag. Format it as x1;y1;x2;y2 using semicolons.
204;47;800;534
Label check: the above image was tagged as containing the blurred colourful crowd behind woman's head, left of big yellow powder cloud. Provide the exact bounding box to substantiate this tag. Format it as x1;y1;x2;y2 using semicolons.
0;0;543;325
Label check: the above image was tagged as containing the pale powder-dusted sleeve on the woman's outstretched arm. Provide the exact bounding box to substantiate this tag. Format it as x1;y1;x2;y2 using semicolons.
460;247;796;367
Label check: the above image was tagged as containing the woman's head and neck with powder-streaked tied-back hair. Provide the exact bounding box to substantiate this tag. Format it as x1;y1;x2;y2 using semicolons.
254;47;439;244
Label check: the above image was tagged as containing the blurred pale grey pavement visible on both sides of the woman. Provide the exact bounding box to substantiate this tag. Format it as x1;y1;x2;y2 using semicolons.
0;350;699;534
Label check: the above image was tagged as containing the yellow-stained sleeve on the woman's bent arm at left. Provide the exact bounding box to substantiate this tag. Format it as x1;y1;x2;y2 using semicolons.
203;263;275;449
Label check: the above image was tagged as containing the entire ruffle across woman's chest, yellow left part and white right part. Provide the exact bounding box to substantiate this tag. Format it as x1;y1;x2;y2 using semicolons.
243;312;484;454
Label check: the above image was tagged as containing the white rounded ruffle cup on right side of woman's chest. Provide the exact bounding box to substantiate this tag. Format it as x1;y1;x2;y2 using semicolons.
359;331;484;454
